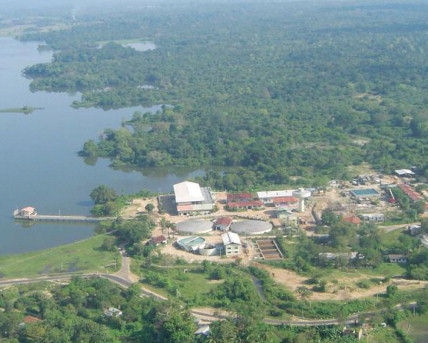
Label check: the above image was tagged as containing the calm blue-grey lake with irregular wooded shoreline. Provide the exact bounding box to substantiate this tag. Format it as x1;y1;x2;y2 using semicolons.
0;38;203;255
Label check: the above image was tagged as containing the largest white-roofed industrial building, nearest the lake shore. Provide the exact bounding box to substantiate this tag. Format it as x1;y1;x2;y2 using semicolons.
174;181;215;216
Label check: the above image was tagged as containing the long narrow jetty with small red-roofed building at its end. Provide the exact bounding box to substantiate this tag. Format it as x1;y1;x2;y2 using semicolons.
13;207;116;223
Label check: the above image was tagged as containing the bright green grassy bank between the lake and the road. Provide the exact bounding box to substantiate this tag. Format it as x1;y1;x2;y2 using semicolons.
0;235;120;278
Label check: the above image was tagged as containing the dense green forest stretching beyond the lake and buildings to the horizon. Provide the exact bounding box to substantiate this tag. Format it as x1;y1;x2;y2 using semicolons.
21;1;428;190
